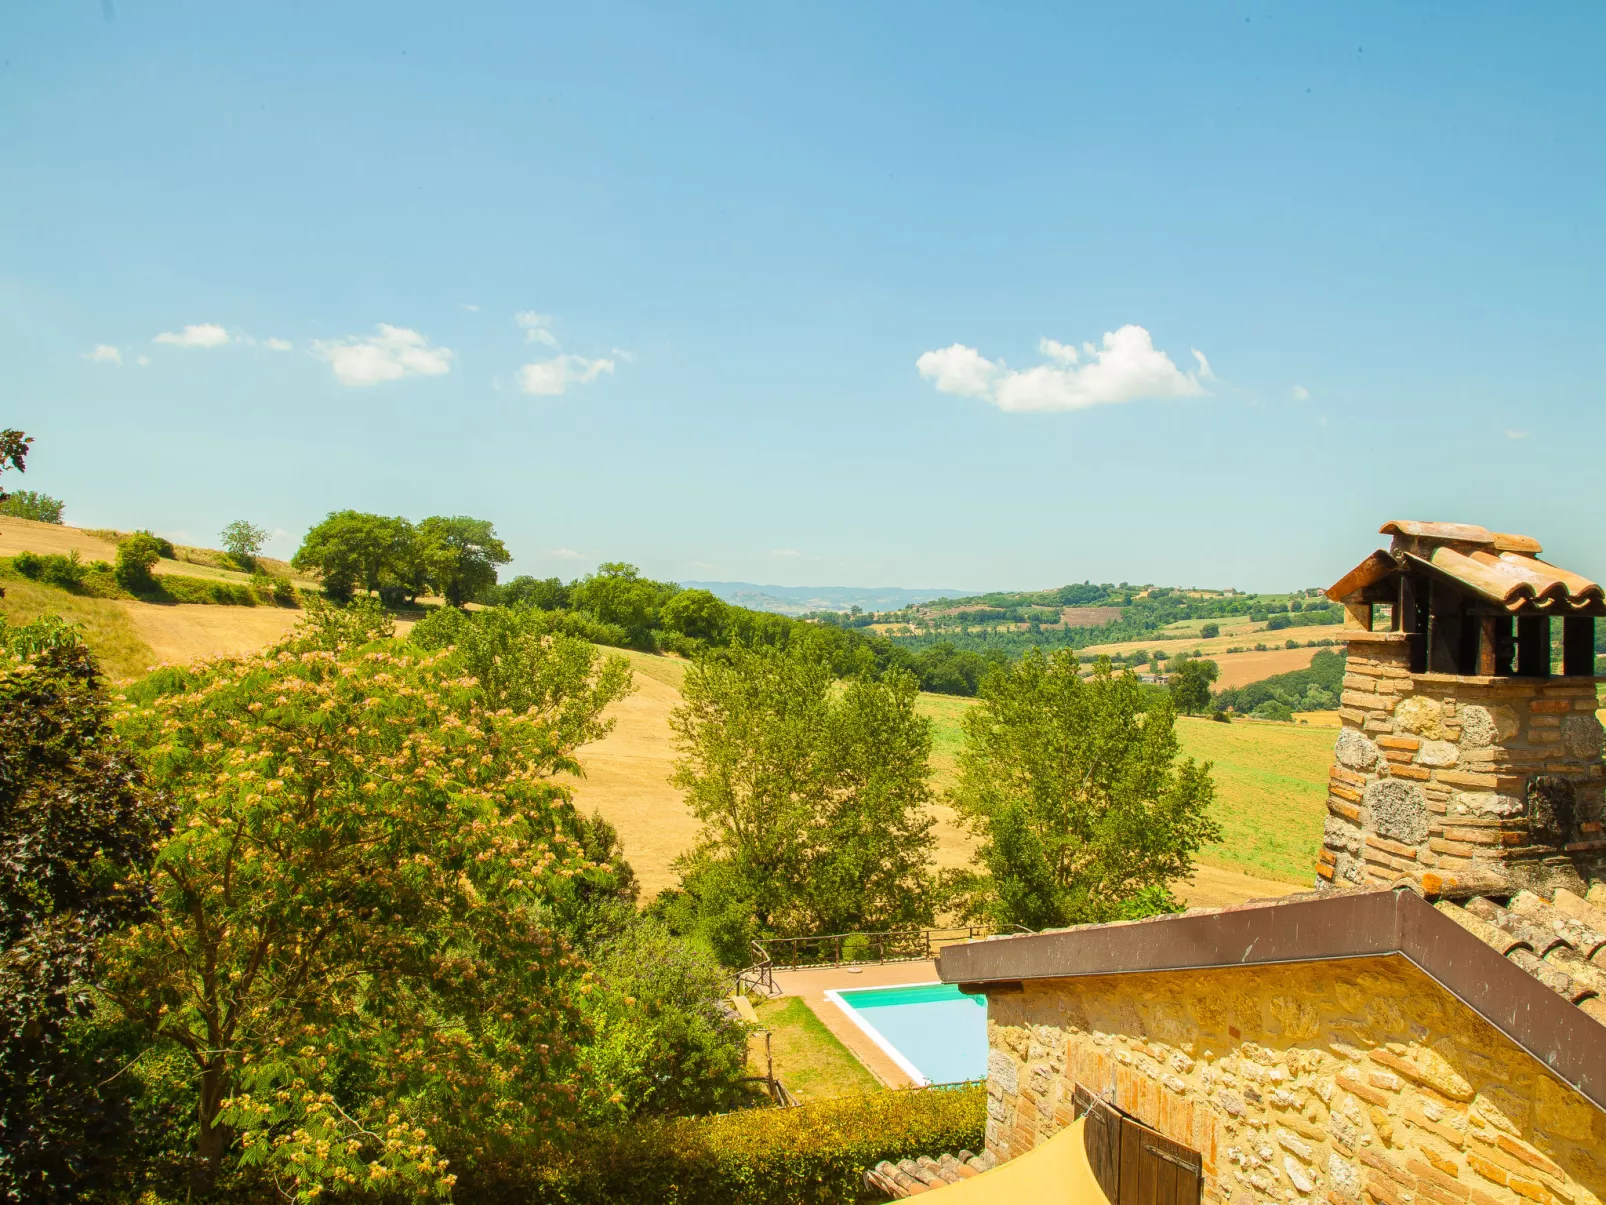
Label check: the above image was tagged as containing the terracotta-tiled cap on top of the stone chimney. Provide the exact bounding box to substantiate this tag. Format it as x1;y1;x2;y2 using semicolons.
1327;519;1606;615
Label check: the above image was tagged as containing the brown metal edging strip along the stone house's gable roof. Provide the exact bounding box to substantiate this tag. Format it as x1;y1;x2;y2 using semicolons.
936;888;1606;1112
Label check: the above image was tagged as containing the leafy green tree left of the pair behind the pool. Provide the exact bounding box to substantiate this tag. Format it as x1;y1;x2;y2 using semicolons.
670;646;933;962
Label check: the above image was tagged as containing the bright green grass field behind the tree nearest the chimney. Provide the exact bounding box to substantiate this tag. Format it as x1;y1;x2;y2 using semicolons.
920;694;1336;884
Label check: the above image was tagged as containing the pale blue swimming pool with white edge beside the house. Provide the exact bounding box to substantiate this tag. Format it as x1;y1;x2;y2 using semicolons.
825;983;988;1085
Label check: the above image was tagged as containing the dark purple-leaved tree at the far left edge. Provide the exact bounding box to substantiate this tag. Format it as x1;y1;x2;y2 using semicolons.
0;619;161;1202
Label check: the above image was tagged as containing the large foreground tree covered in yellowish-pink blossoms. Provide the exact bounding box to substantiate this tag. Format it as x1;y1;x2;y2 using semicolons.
108;604;632;1195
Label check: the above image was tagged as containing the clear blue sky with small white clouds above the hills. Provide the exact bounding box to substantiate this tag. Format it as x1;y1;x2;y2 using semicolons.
0;0;1606;588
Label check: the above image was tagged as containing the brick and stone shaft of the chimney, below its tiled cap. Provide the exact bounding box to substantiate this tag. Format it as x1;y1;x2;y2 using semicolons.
1317;631;1606;892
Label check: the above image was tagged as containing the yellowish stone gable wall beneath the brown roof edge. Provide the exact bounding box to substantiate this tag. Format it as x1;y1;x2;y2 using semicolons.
988;958;1606;1205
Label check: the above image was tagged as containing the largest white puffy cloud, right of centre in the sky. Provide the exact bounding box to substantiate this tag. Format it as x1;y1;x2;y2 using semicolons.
915;325;1216;413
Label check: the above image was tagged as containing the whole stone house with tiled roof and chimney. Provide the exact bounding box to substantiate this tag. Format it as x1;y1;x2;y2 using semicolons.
938;524;1606;1205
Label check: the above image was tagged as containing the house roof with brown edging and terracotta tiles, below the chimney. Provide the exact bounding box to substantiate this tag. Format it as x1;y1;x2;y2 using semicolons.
936;885;1606;1110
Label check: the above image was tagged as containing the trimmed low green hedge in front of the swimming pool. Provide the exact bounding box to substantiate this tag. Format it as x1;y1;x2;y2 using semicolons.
475;1085;988;1205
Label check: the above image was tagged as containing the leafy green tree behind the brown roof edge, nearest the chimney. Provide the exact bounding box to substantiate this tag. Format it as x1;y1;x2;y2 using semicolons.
954;651;1221;929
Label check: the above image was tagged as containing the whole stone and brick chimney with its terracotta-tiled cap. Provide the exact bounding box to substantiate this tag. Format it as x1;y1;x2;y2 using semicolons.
1317;522;1606;898
